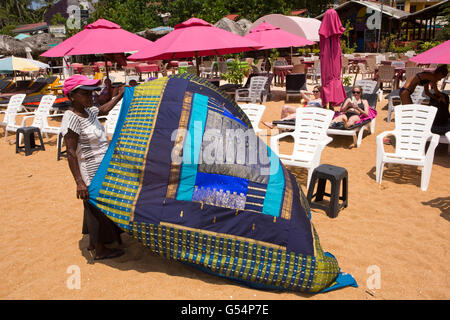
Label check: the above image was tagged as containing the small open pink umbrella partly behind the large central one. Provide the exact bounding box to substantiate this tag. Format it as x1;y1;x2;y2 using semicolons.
245;22;314;50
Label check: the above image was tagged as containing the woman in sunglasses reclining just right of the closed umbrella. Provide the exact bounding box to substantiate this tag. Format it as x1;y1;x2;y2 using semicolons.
331;86;369;129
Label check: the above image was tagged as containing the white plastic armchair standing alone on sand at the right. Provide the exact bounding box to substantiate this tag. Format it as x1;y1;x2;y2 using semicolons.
376;104;439;191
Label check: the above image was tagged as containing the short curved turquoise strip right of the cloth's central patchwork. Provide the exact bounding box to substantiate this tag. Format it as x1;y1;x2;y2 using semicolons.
262;147;284;217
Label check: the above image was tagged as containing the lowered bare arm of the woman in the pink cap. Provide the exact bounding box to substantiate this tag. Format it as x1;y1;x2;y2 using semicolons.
64;129;89;200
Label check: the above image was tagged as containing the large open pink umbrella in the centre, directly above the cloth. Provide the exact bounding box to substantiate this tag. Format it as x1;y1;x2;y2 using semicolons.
128;18;262;74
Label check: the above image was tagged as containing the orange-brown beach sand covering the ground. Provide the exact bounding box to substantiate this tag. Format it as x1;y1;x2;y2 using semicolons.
0;72;450;300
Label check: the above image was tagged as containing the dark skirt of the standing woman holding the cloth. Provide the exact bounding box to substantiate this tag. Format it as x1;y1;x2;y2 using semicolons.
82;201;123;245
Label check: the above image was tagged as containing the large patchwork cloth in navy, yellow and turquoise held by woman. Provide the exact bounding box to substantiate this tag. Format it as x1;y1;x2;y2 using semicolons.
89;74;356;292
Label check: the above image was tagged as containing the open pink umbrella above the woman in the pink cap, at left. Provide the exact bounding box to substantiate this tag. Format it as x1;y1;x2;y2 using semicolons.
41;19;153;57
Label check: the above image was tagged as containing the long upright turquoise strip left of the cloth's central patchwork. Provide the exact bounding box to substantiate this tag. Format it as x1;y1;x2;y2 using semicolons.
177;94;208;201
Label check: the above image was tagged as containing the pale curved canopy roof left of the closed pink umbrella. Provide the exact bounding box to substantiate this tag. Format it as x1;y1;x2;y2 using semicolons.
250;14;321;42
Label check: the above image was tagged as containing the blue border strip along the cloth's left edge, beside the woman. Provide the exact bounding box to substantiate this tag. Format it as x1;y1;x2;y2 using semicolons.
89;87;135;205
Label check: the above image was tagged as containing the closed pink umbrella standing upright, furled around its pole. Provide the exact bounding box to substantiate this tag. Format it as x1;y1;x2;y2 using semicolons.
319;9;346;105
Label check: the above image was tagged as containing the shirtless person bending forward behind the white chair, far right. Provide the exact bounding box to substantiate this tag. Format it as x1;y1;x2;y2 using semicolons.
400;65;448;104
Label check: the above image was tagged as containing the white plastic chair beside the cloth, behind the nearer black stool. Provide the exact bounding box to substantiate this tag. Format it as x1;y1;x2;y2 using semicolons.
270;107;334;189
